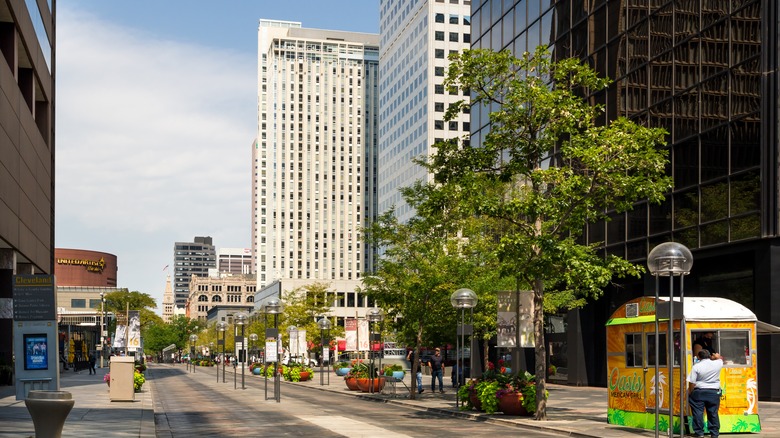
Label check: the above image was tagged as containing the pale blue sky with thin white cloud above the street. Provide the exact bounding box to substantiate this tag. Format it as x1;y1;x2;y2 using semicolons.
55;0;379;313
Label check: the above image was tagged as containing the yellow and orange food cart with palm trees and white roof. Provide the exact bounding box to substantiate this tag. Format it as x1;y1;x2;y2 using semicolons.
606;296;780;433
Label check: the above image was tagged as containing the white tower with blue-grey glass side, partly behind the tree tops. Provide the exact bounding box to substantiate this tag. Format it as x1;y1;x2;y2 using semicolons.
378;0;471;220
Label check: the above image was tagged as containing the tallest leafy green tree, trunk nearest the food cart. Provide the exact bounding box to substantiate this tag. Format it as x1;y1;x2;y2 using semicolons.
424;48;671;420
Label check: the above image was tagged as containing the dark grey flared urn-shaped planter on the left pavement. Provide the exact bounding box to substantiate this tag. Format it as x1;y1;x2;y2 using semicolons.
24;391;76;438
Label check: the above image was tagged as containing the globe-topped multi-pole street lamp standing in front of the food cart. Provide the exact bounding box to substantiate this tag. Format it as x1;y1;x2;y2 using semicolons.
647;242;693;437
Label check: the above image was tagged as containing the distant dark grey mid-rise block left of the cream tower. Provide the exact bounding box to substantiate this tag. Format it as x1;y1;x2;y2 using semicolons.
173;237;217;308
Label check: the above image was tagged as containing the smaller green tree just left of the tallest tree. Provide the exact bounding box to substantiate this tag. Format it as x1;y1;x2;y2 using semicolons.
363;181;512;397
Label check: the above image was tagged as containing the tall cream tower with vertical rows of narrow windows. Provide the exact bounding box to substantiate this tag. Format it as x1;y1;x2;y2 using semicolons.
253;20;379;304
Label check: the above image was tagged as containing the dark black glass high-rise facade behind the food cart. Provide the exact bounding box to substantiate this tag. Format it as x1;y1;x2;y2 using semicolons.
471;0;780;400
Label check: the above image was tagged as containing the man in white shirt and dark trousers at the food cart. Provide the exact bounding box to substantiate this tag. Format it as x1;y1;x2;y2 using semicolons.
688;349;723;438
